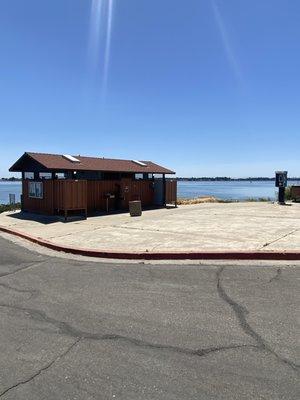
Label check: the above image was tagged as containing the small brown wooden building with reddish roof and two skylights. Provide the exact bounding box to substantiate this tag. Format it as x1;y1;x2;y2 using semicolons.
9;152;177;216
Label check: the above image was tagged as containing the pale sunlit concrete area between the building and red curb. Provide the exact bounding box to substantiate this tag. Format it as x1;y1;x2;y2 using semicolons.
0;202;300;253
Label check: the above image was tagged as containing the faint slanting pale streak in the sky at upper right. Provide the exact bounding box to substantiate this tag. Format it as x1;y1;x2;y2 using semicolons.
211;0;242;81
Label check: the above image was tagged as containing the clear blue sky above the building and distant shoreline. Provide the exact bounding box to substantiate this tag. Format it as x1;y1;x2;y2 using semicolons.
0;0;300;177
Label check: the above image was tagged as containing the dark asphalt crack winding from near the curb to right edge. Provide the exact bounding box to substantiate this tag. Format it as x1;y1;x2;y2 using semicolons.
217;266;300;371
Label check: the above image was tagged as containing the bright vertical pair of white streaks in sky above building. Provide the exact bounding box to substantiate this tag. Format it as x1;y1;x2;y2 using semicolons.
88;0;114;97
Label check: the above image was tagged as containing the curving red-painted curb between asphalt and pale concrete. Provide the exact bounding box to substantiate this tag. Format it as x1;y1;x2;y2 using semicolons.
0;226;300;260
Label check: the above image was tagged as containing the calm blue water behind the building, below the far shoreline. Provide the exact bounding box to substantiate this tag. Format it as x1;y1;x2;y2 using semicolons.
0;181;300;204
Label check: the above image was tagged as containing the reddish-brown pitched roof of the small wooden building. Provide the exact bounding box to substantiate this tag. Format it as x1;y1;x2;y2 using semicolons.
10;152;175;174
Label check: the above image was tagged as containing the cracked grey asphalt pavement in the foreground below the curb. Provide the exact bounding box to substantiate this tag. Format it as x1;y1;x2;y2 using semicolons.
0;237;300;400
